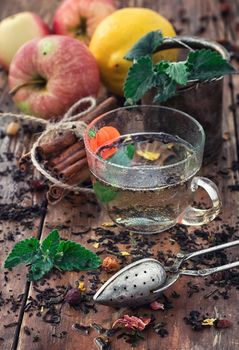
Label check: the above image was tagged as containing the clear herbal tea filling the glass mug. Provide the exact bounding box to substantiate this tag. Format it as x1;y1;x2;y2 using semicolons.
92;133;197;233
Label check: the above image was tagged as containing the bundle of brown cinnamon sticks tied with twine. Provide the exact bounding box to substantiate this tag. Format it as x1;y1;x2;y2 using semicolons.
18;97;117;204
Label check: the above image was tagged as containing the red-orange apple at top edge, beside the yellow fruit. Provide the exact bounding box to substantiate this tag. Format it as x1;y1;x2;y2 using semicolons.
53;0;116;43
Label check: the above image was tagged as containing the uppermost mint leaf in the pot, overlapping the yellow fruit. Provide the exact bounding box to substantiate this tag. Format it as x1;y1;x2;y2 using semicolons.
124;30;163;61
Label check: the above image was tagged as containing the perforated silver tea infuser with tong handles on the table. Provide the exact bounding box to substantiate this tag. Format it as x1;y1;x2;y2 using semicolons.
94;240;239;307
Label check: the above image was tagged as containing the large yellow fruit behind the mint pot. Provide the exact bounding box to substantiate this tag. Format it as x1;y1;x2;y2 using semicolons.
89;8;177;95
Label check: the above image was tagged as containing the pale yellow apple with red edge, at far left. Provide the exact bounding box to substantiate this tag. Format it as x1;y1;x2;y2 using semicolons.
0;12;50;70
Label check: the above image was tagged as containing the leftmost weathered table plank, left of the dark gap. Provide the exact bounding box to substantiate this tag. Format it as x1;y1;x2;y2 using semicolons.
0;1;50;342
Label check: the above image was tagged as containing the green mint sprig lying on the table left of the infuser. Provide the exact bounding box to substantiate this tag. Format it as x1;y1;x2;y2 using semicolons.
4;230;101;281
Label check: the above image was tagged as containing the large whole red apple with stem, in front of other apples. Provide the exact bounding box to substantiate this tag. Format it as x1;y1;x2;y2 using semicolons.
9;35;100;119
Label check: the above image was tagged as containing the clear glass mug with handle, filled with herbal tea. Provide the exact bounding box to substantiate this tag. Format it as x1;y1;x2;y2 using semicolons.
84;105;221;234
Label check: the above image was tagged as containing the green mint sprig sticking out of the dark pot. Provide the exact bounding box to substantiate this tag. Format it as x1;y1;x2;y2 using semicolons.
124;31;235;105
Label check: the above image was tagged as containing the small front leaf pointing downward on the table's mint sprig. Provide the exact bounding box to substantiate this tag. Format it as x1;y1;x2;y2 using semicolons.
28;254;53;281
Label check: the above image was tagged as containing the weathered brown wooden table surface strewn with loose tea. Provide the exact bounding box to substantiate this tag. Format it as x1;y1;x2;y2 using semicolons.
0;0;239;350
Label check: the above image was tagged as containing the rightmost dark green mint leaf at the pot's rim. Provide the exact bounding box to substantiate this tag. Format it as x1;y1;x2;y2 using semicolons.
186;49;235;80
